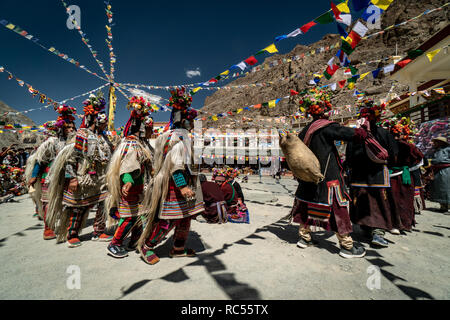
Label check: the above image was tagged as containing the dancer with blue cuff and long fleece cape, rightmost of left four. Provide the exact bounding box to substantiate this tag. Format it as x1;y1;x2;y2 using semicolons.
138;88;205;264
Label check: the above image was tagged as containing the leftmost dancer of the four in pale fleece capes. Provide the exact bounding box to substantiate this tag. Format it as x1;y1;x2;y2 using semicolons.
26;105;75;240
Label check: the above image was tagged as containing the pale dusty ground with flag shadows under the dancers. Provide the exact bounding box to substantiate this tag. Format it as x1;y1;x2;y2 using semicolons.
0;176;450;300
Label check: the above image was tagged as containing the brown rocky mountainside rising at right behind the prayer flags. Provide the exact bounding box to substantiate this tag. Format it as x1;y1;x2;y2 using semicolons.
201;0;450;128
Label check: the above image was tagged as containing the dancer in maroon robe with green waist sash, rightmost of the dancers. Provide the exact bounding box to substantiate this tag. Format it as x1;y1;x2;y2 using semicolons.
381;117;424;234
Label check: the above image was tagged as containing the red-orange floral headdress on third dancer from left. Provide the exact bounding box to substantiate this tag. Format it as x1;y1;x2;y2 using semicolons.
123;96;153;137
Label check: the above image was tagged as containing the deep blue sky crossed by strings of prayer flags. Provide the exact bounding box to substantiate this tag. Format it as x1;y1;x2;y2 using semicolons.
0;0;339;127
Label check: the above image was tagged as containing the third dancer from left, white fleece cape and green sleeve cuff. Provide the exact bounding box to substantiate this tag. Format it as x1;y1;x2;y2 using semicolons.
106;97;153;258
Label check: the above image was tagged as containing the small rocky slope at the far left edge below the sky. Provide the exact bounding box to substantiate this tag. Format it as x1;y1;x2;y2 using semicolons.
0;101;44;148
